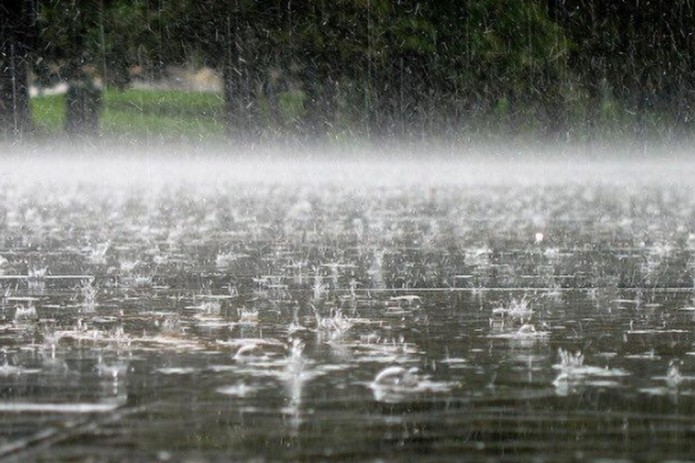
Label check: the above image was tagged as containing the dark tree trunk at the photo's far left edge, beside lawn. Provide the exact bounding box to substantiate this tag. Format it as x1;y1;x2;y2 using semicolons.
0;1;34;138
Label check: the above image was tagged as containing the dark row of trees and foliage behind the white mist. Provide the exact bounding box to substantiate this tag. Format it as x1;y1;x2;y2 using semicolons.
0;0;695;138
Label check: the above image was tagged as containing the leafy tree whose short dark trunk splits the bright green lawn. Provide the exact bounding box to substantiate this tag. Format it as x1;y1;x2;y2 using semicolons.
34;0;173;135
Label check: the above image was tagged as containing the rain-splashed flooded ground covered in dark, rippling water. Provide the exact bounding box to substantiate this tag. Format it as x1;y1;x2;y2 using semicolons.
0;155;695;461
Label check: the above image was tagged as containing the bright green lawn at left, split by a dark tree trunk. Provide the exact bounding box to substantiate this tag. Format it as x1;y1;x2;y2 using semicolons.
31;89;225;139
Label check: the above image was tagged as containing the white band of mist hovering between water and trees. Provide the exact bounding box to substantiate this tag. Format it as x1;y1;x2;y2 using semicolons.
2;141;693;189
